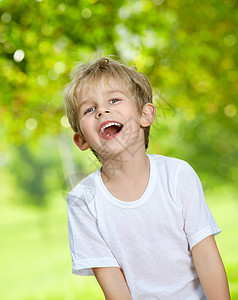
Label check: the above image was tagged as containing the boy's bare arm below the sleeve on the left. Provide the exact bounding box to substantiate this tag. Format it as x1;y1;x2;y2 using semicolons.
93;267;132;300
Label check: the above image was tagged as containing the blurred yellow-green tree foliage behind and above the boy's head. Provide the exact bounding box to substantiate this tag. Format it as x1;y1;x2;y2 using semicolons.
0;0;238;204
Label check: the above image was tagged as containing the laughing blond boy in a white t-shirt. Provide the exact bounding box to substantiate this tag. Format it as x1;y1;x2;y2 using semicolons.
64;58;230;300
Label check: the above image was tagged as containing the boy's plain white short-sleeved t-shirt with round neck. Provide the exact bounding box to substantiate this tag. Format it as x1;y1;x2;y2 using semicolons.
67;155;221;300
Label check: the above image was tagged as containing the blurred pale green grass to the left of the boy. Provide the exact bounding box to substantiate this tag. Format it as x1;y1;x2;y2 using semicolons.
0;195;103;300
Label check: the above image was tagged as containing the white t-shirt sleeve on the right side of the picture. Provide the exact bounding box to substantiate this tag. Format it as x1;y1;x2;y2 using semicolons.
177;163;221;249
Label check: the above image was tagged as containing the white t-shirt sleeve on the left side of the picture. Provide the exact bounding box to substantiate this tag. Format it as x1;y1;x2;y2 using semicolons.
67;193;120;275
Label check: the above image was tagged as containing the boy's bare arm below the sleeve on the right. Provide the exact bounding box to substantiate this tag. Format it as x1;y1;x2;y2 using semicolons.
192;235;230;300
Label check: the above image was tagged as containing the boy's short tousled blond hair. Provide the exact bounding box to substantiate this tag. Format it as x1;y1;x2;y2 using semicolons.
64;57;152;149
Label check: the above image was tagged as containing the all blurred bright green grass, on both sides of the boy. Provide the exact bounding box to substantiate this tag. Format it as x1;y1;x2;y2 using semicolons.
0;187;238;300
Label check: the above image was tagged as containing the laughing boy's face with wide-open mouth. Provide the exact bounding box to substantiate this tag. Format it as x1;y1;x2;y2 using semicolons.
74;78;153;157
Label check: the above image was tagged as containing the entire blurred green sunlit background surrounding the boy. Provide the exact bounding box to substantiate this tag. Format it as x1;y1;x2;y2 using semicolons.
0;0;238;300
